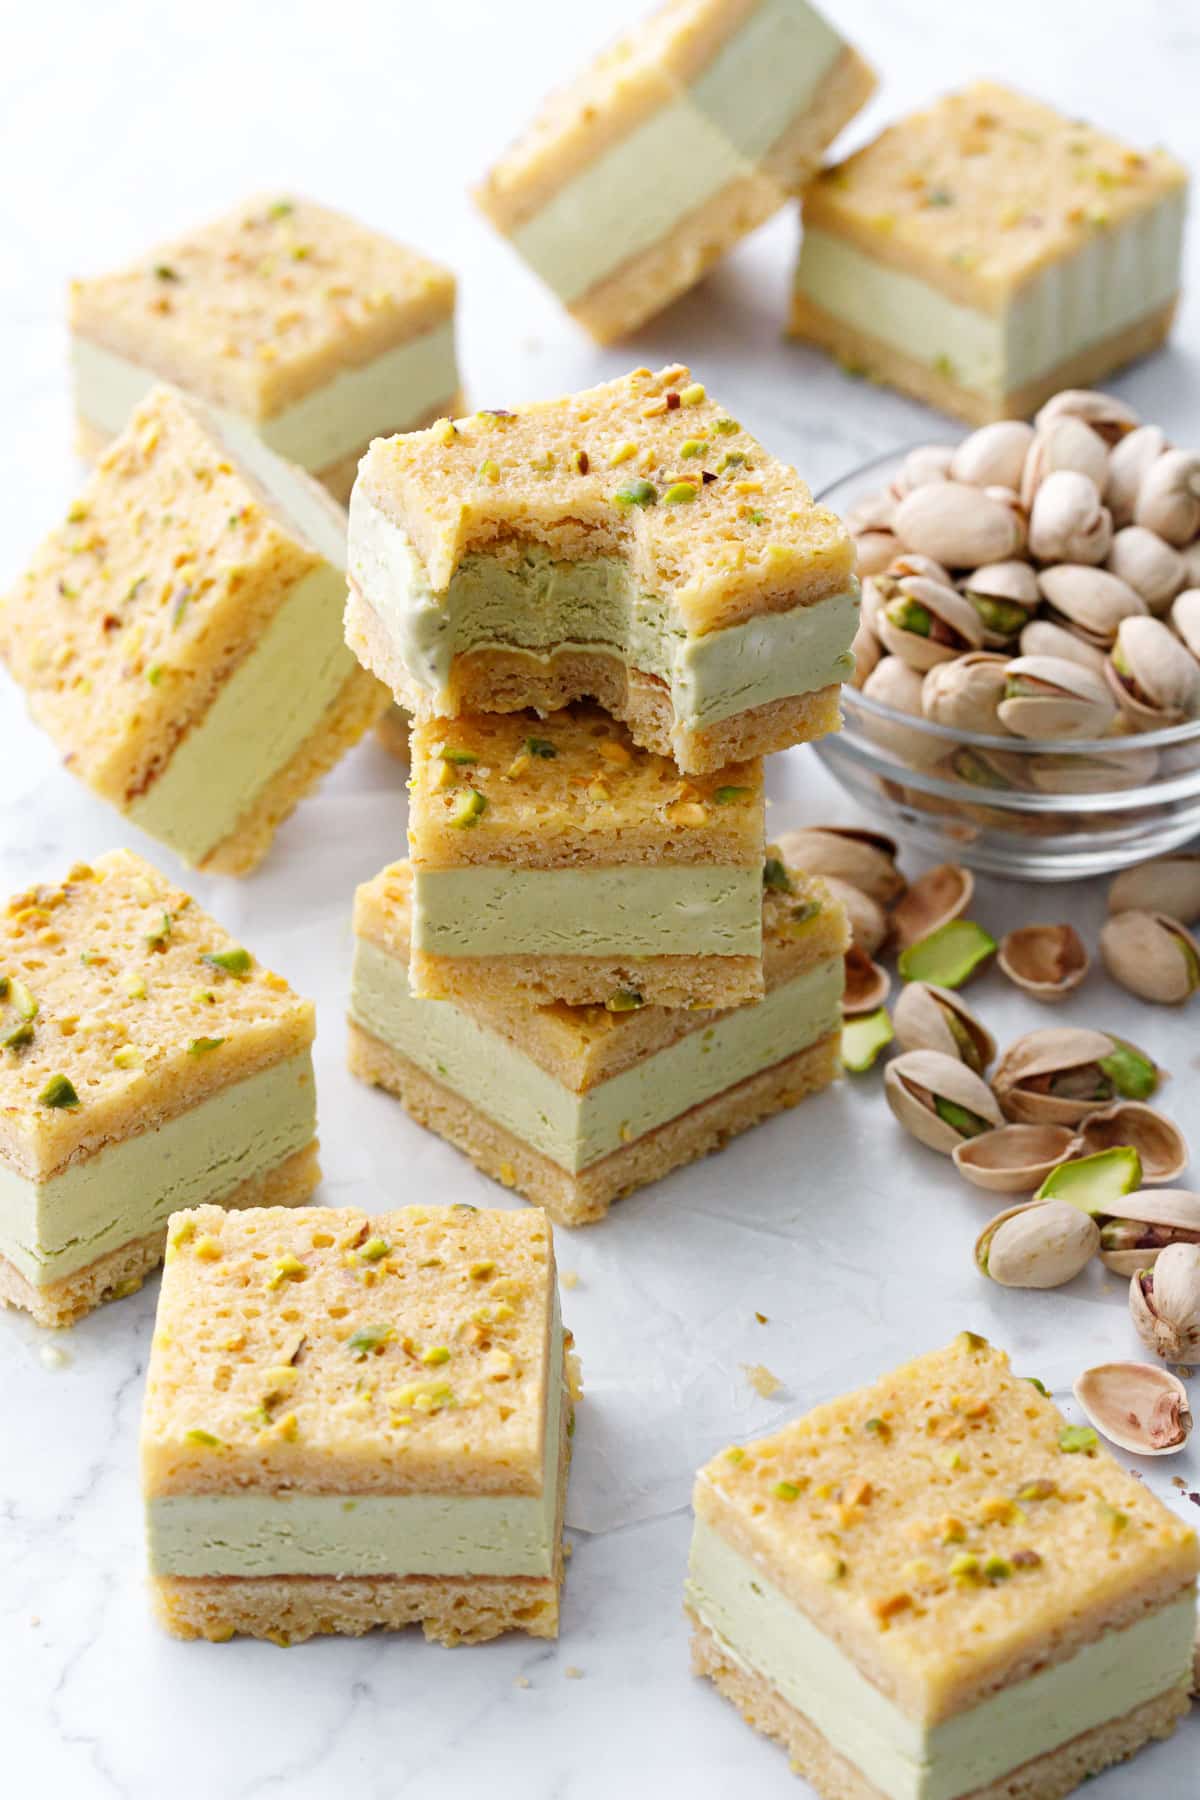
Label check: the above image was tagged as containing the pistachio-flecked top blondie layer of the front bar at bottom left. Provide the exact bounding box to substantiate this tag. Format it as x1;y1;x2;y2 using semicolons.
142;1206;560;1498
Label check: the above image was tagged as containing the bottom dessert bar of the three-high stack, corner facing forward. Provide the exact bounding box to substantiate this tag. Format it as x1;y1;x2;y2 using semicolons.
349;857;849;1226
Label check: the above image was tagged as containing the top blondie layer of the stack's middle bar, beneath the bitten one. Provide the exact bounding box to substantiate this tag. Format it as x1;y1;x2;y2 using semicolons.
408;706;763;869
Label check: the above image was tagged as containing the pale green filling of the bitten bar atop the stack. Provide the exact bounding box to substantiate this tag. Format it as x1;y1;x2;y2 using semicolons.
349;488;858;731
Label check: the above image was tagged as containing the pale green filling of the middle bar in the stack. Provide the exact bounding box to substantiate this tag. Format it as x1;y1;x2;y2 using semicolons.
412;862;763;956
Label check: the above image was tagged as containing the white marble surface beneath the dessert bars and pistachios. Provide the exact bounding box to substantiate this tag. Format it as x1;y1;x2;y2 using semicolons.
0;0;1200;1800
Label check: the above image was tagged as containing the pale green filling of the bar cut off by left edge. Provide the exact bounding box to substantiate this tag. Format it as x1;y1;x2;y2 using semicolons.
0;1051;317;1287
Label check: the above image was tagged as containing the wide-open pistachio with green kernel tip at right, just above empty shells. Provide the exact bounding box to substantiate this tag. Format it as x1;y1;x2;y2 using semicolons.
991;1026;1160;1125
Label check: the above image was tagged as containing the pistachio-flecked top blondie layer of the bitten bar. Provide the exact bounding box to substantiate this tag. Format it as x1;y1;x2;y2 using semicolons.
347;364;855;635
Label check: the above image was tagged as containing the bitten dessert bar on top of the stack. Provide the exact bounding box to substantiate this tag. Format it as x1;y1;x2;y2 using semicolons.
345;364;858;774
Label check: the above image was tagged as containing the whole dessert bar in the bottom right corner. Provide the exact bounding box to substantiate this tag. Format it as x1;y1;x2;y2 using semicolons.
687;1332;1200;1800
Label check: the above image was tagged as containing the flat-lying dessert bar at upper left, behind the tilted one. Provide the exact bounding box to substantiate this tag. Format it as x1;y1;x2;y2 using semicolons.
70;196;459;502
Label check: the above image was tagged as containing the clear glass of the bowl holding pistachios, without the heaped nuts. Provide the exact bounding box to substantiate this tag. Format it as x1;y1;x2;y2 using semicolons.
813;450;1200;882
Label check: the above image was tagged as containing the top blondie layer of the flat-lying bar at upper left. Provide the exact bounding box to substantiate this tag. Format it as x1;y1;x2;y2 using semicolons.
70;194;455;421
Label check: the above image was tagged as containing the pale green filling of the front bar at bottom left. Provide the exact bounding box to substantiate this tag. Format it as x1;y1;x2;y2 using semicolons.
146;1298;563;1577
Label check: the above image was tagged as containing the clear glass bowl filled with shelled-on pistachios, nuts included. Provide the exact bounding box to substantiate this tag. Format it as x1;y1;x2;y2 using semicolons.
817;389;1200;880
